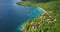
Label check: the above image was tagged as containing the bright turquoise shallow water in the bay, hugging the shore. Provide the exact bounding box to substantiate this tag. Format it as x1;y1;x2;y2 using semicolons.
17;7;44;32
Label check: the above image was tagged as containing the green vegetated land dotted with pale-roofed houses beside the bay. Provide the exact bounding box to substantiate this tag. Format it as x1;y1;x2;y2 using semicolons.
17;0;60;32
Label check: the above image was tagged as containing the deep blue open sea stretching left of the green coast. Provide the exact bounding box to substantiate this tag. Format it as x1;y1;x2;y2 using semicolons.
0;0;43;32
